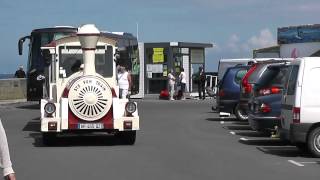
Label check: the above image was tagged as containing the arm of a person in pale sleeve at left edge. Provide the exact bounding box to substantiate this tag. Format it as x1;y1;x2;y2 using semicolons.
0;119;16;180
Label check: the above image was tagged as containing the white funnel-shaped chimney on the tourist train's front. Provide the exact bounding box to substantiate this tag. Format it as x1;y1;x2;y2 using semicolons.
77;24;100;75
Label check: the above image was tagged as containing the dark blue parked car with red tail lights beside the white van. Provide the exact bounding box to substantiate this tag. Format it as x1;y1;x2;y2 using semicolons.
248;62;290;132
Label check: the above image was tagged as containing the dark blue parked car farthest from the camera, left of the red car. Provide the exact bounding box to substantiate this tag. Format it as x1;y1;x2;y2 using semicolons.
216;65;249;117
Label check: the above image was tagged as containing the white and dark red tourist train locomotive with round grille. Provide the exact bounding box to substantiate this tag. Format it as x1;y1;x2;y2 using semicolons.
41;24;139;144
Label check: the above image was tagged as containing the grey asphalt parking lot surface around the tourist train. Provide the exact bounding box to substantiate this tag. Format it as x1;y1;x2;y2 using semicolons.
0;99;320;180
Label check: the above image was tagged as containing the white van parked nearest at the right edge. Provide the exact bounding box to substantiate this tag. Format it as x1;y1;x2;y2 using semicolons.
280;57;320;157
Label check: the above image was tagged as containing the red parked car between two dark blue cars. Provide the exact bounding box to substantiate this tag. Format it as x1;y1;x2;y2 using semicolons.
239;59;284;121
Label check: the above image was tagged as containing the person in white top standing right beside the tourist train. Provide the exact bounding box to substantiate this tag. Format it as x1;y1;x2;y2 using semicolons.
118;66;131;99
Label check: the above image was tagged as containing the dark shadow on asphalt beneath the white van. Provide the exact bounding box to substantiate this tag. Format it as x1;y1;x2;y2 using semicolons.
257;146;313;158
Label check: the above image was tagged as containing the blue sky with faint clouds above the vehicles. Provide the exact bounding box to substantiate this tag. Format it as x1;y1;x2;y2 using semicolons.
0;0;320;74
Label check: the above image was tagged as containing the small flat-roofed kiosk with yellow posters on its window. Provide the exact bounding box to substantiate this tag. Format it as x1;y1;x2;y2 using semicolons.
139;42;213;94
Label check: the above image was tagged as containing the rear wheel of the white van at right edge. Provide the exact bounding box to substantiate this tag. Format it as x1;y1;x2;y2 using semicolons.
308;127;320;157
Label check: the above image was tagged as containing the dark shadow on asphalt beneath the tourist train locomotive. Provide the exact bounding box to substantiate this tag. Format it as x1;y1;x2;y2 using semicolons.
29;133;131;147
